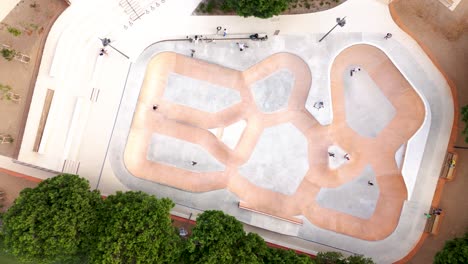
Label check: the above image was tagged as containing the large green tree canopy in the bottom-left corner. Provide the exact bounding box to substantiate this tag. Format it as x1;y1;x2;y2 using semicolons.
2;174;101;263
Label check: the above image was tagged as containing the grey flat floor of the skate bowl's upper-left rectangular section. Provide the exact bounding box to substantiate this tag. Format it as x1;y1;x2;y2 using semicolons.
164;72;241;113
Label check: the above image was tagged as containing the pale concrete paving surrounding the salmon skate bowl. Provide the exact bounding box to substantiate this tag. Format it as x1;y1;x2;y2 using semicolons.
0;0;453;263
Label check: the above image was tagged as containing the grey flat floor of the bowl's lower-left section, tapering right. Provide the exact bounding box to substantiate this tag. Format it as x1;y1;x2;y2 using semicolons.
147;133;225;172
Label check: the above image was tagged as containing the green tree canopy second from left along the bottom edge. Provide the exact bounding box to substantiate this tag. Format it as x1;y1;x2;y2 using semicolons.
90;191;181;264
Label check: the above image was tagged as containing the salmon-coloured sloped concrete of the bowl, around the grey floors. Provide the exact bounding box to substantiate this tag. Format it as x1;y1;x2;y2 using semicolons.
124;44;425;240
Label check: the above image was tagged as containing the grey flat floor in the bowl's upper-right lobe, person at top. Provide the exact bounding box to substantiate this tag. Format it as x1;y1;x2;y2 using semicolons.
343;65;396;137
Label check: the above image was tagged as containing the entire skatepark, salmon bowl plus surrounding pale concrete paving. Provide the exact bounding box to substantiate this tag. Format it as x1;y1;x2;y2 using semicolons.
3;0;453;263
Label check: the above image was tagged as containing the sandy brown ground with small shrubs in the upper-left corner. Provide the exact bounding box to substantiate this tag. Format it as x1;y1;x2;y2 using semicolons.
0;0;67;157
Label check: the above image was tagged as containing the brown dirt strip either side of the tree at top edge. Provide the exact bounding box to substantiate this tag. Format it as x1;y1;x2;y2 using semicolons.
194;0;346;16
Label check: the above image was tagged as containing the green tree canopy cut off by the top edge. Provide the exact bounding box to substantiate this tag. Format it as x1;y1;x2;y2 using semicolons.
222;0;289;18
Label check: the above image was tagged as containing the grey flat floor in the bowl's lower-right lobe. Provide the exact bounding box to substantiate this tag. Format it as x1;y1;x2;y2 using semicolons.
315;165;380;219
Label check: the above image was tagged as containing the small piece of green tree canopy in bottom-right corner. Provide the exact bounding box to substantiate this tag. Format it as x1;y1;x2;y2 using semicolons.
434;233;468;264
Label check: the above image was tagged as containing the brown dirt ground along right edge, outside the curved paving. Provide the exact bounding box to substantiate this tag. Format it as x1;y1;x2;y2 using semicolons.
394;0;468;264
